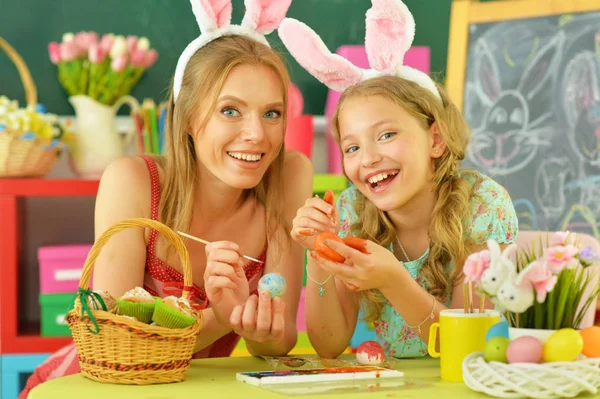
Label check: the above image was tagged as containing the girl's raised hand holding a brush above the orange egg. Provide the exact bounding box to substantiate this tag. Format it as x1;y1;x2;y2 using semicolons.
291;190;339;249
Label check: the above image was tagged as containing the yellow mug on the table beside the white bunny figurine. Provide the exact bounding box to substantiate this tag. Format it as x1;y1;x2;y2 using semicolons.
427;309;500;382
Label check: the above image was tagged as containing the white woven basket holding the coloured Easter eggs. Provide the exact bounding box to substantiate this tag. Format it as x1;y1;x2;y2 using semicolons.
463;352;600;399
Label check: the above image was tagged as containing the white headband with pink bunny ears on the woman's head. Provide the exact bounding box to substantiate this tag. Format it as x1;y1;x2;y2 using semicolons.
173;0;292;100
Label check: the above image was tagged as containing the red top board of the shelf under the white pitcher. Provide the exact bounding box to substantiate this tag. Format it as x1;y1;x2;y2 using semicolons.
0;179;100;197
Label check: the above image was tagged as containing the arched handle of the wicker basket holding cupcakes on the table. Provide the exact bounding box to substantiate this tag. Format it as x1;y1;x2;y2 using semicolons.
79;218;194;299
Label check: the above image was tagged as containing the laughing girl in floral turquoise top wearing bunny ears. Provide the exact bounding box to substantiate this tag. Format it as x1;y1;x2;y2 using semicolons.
279;0;518;358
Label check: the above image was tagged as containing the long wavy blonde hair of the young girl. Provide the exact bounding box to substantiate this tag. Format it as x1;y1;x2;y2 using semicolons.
332;76;474;321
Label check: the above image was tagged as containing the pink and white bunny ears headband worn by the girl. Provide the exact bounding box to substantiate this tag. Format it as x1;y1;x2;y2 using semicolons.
278;0;441;99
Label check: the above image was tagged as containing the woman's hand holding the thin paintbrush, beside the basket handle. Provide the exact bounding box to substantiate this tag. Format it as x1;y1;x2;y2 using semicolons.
204;241;249;326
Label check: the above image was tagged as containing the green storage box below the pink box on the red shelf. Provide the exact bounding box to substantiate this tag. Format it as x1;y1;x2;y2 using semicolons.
40;292;75;337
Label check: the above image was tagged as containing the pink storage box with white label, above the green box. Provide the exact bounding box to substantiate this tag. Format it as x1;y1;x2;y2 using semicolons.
38;244;92;294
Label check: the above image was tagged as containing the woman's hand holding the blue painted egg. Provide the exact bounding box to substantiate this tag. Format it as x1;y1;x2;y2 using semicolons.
229;291;285;343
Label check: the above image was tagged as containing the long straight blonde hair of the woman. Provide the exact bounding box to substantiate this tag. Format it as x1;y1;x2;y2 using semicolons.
152;36;290;256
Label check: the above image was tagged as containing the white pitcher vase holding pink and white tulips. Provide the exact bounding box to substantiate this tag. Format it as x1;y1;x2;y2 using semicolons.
69;95;140;179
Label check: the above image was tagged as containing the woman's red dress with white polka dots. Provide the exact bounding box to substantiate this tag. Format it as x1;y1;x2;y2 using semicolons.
19;156;267;399
